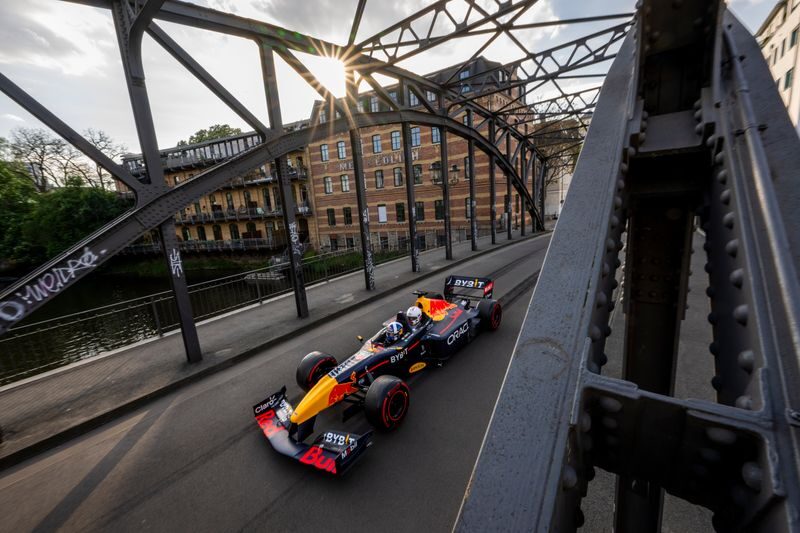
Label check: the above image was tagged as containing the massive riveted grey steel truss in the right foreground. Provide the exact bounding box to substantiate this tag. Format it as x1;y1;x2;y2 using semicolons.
456;0;800;532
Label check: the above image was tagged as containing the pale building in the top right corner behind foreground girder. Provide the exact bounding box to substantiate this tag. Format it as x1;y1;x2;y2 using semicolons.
756;0;800;132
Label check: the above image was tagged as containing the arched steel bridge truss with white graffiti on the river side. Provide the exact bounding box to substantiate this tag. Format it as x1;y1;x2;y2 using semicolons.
0;0;630;362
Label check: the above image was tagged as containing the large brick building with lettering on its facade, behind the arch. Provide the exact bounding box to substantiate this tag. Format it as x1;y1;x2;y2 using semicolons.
308;57;530;250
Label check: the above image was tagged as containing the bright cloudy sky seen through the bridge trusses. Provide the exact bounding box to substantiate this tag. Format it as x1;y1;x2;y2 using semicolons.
0;0;775;153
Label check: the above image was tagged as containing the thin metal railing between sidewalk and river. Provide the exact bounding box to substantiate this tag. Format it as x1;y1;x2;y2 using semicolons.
0;227;488;384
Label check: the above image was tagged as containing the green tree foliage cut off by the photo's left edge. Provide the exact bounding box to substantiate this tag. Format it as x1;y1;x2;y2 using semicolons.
0;157;37;266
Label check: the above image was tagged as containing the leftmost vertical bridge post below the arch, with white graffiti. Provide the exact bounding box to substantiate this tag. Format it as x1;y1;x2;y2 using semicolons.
158;218;203;363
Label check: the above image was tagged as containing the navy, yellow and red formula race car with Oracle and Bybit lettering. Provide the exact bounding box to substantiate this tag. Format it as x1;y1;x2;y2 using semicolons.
253;276;503;474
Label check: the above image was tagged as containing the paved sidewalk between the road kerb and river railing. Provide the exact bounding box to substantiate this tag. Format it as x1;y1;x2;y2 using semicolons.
0;227;542;468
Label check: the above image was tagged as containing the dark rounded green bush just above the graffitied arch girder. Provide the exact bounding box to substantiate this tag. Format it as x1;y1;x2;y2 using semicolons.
23;182;129;264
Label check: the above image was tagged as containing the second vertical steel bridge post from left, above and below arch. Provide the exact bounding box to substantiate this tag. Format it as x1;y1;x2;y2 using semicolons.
259;43;308;318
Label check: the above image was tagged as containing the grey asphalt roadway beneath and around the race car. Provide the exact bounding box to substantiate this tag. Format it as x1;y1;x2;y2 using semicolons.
0;238;549;532
